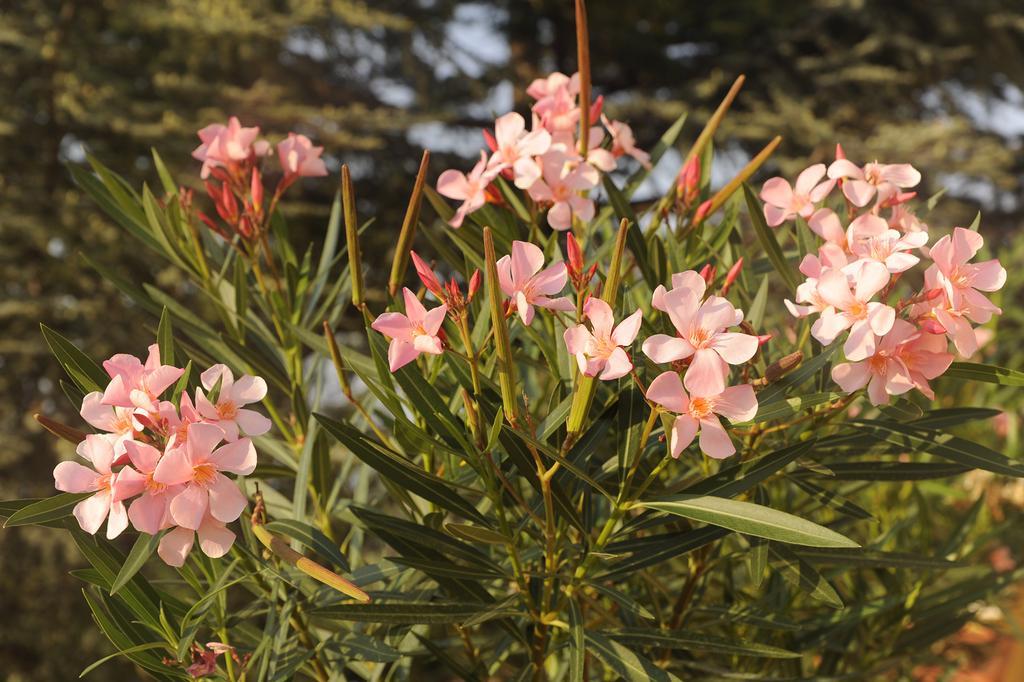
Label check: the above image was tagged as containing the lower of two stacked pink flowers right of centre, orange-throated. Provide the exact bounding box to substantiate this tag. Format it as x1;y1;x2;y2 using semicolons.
647;372;758;460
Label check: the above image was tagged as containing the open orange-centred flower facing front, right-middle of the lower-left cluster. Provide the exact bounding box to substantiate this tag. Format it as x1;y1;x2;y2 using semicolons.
153;424;256;530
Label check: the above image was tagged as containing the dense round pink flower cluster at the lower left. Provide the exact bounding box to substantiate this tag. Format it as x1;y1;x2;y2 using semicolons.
53;344;270;566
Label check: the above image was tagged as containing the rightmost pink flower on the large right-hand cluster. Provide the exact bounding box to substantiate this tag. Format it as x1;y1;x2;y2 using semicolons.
925;227;1007;325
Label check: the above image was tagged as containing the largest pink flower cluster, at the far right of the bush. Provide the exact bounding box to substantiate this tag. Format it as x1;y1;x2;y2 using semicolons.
761;146;1007;404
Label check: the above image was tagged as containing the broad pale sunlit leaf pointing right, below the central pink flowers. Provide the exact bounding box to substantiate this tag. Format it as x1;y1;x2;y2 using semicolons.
637;495;858;547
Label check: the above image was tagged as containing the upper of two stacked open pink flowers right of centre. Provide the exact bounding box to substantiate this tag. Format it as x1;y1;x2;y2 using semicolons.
643;288;758;396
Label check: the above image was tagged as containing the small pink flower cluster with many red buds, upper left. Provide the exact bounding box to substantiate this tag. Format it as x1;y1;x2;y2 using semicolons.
193;116;327;241
